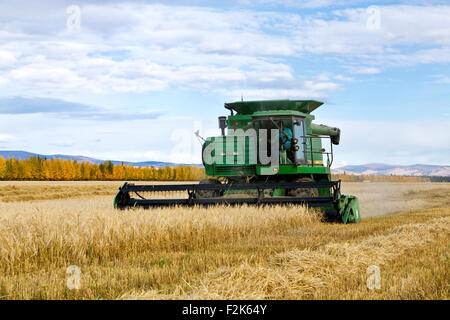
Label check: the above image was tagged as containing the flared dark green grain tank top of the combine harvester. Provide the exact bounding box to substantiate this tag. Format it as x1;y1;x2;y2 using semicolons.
225;100;323;115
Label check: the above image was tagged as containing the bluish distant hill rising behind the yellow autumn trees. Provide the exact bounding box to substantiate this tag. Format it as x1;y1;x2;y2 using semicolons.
0;151;203;168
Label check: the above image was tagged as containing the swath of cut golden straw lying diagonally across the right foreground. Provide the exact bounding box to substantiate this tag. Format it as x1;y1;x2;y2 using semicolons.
125;217;450;299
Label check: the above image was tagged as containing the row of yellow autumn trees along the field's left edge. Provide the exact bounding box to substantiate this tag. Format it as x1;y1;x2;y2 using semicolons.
0;157;205;181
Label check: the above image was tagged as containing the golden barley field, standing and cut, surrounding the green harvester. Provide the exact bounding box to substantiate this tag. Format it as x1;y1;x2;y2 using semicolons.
0;181;450;299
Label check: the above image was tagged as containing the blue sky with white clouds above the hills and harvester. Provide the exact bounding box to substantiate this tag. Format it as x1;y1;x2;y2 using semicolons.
0;0;450;167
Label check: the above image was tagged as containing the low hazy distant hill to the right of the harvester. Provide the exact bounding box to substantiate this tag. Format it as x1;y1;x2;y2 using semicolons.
333;163;450;177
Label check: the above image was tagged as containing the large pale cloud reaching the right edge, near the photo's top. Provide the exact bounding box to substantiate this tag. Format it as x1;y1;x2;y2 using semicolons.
299;5;450;55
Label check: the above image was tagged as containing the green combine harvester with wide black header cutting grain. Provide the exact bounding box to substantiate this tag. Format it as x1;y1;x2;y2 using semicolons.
114;100;360;223
